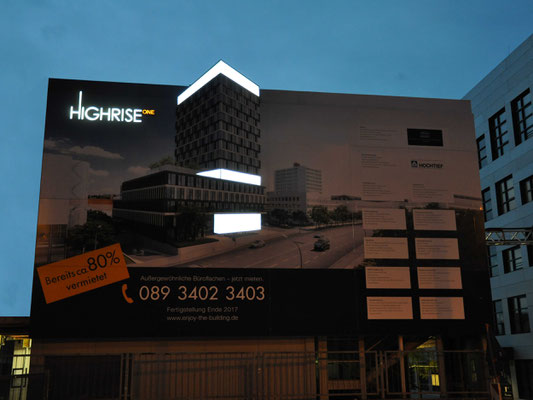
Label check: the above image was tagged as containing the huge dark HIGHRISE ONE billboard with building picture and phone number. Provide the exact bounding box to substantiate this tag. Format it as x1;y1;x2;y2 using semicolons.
31;76;490;337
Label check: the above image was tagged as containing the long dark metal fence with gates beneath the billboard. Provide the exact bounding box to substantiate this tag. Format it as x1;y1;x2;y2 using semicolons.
0;349;490;400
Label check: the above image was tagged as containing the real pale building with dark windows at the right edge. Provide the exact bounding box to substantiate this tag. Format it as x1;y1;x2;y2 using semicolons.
464;36;533;399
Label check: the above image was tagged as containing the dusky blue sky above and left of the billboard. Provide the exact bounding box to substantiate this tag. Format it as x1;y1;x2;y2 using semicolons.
0;0;533;316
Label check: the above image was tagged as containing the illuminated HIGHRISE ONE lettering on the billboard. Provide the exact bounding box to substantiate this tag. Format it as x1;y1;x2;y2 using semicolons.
69;90;155;123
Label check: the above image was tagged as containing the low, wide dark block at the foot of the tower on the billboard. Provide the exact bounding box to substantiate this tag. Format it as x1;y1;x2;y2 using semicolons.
113;166;264;242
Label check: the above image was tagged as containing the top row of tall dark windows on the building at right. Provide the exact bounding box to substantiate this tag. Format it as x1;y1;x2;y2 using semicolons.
477;89;533;169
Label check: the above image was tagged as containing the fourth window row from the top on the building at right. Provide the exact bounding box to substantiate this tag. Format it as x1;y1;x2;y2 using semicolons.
492;295;531;335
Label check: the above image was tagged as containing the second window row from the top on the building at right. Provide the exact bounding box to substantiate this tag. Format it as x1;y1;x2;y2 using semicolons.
481;175;533;222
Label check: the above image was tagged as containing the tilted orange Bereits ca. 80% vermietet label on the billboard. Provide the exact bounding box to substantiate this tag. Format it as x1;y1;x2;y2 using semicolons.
37;243;130;304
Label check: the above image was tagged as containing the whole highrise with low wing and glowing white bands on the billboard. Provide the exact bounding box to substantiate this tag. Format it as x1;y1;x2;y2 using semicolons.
113;62;264;242
